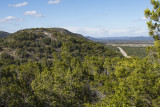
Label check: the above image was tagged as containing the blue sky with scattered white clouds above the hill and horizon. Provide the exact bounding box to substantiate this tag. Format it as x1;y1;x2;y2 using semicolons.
0;0;152;37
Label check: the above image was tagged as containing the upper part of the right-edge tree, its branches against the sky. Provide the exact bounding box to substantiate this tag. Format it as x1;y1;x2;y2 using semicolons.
144;0;160;40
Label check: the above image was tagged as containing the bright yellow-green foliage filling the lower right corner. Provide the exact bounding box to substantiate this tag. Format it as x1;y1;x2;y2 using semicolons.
89;58;160;107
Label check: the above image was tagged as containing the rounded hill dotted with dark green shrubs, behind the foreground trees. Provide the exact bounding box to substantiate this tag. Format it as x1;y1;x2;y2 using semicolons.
0;28;121;63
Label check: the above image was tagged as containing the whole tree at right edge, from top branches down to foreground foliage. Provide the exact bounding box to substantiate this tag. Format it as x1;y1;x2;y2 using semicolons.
144;0;160;59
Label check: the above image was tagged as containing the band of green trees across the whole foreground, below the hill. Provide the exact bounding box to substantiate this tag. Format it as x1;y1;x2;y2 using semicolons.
0;41;160;107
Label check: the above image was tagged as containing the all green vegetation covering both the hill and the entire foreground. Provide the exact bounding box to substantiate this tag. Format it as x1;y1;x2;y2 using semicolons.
0;25;160;107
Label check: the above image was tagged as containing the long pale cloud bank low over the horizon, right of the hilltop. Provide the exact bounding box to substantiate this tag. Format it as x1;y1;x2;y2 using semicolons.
65;27;148;37
